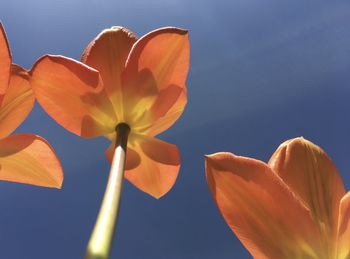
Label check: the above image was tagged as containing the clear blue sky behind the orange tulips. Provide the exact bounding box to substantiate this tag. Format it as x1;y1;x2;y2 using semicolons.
0;0;350;259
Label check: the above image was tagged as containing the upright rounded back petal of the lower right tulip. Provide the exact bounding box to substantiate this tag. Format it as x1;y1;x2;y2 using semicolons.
269;138;345;253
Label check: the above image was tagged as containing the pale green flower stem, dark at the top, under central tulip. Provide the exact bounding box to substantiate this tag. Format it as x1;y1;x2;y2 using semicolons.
85;123;130;259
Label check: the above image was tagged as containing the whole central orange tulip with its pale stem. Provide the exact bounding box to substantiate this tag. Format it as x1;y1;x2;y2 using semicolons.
30;27;189;258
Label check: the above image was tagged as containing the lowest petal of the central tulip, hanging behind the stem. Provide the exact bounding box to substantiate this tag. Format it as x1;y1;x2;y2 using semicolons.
107;134;180;199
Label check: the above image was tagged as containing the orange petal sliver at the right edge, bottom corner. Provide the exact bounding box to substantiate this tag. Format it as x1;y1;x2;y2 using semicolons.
337;192;350;259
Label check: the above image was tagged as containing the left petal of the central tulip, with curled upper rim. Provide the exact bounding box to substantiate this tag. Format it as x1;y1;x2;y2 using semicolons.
30;56;116;137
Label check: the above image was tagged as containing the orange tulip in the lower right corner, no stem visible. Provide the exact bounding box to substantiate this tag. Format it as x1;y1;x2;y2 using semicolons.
206;138;350;259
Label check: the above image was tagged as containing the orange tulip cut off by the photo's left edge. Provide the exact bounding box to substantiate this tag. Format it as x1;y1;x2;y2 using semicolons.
0;23;63;188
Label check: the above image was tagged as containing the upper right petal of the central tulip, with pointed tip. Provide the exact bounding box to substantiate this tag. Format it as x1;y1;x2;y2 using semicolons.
123;28;190;136
